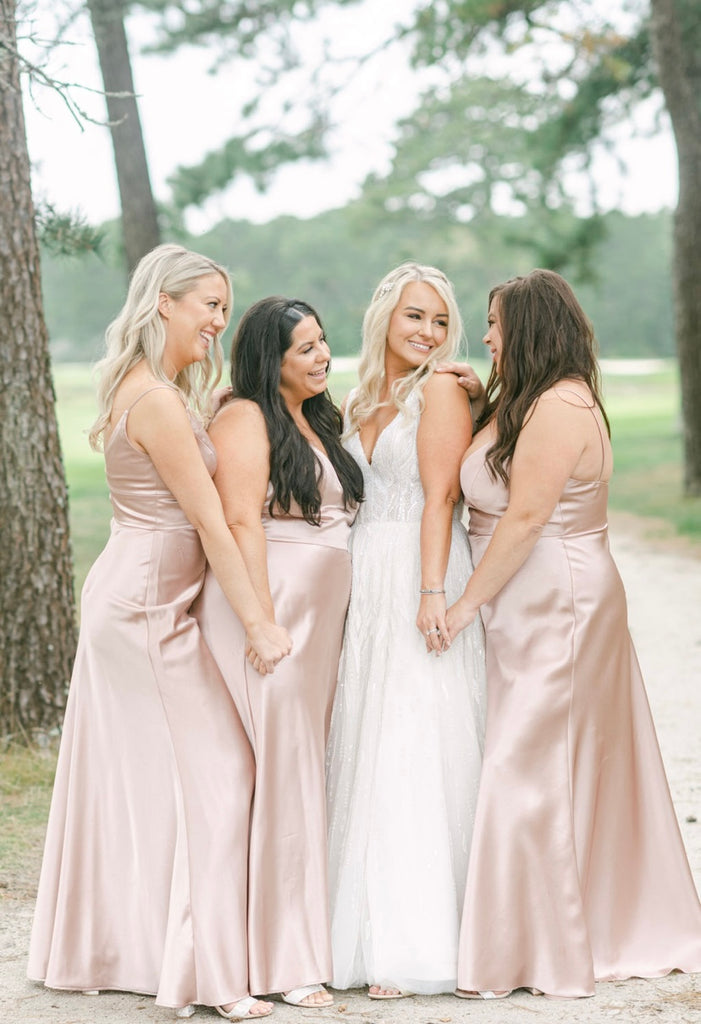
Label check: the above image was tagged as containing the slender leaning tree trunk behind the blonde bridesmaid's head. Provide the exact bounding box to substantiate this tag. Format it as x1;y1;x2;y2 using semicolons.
87;0;161;272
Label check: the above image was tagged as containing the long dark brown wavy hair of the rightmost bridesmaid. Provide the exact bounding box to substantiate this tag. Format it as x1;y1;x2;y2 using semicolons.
475;270;611;484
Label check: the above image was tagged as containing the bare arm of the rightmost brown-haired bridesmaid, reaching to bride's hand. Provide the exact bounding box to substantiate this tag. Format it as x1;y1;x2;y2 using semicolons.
447;392;594;637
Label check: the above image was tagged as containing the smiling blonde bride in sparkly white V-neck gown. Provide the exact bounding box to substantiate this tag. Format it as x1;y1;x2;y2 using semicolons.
327;263;485;998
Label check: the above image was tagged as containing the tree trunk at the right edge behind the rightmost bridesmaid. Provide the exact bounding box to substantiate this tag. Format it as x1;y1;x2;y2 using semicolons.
650;0;701;497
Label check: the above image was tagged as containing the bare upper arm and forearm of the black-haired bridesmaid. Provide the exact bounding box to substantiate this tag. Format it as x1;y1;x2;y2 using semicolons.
210;400;275;622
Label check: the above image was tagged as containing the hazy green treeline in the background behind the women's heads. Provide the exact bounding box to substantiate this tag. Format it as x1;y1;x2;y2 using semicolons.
42;202;674;361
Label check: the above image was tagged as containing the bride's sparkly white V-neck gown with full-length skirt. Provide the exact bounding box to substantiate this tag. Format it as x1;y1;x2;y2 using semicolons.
327;395;485;993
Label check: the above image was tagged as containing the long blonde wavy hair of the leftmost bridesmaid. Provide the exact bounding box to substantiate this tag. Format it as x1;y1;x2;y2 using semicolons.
88;245;233;451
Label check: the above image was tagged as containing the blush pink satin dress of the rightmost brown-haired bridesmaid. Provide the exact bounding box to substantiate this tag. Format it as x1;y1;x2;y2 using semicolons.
457;447;701;996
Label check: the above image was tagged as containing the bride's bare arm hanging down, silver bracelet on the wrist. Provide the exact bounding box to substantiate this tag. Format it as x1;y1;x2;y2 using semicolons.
417;374;472;654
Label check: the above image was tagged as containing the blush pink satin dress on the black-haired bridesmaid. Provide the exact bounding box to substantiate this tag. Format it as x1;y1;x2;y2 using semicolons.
193;450;355;991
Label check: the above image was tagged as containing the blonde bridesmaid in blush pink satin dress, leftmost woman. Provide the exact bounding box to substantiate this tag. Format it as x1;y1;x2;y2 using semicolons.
29;245;291;1020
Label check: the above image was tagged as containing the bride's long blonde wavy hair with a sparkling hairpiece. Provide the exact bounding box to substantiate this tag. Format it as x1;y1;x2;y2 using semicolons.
346;261;463;435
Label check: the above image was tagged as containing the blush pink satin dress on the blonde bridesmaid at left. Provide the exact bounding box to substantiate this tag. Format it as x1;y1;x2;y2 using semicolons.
28;389;253;1007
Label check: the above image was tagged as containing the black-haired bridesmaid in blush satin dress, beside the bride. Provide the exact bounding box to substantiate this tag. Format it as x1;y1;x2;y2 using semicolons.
194;296;362;1008
